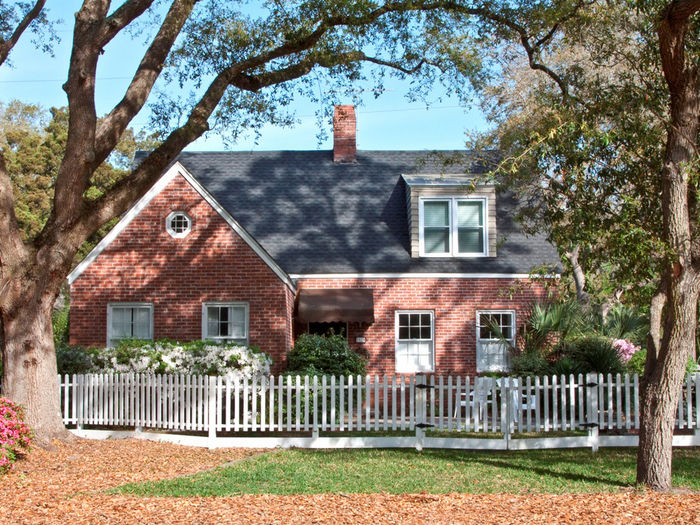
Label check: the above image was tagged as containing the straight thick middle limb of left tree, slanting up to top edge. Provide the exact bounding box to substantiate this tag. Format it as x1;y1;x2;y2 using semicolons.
95;0;198;165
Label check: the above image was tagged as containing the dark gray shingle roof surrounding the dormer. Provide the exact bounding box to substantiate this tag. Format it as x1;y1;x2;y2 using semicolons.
164;151;558;274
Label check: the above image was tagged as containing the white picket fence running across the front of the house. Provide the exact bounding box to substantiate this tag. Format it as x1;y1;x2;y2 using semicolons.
59;374;700;449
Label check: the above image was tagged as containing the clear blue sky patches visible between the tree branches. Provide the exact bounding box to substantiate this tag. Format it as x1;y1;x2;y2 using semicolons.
0;0;486;151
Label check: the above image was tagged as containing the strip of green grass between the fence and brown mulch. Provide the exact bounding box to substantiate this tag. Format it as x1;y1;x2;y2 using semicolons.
114;449;700;497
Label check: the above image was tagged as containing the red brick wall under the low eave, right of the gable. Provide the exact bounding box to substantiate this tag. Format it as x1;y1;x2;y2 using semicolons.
295;279;545;375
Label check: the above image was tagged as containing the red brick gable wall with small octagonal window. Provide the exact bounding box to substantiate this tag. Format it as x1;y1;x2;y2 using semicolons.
70;176;294;372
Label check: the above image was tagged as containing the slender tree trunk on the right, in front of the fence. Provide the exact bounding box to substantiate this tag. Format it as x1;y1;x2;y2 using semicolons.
637;1;700;491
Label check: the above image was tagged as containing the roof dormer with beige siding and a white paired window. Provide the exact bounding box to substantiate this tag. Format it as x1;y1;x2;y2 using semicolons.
402;174;496;258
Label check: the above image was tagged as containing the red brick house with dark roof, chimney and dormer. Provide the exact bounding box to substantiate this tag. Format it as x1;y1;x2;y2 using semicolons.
68;106;558;374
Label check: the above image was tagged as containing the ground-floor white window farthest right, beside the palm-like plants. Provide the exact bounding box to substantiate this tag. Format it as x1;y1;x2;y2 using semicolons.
476;310;515;372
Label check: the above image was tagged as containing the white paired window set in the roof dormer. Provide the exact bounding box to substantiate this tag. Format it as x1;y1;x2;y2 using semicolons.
419;197;488;257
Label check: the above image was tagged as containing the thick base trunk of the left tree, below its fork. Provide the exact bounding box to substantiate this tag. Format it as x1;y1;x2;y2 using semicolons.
2;287;71;445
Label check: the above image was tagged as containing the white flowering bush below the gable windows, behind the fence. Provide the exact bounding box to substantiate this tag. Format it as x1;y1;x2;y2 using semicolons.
76;339;272;379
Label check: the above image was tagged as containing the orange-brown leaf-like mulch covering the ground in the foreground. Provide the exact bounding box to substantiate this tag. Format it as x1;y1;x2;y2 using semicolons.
0;439;700;525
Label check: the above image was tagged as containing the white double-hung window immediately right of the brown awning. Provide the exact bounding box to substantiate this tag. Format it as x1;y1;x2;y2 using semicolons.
395;310;435;374
